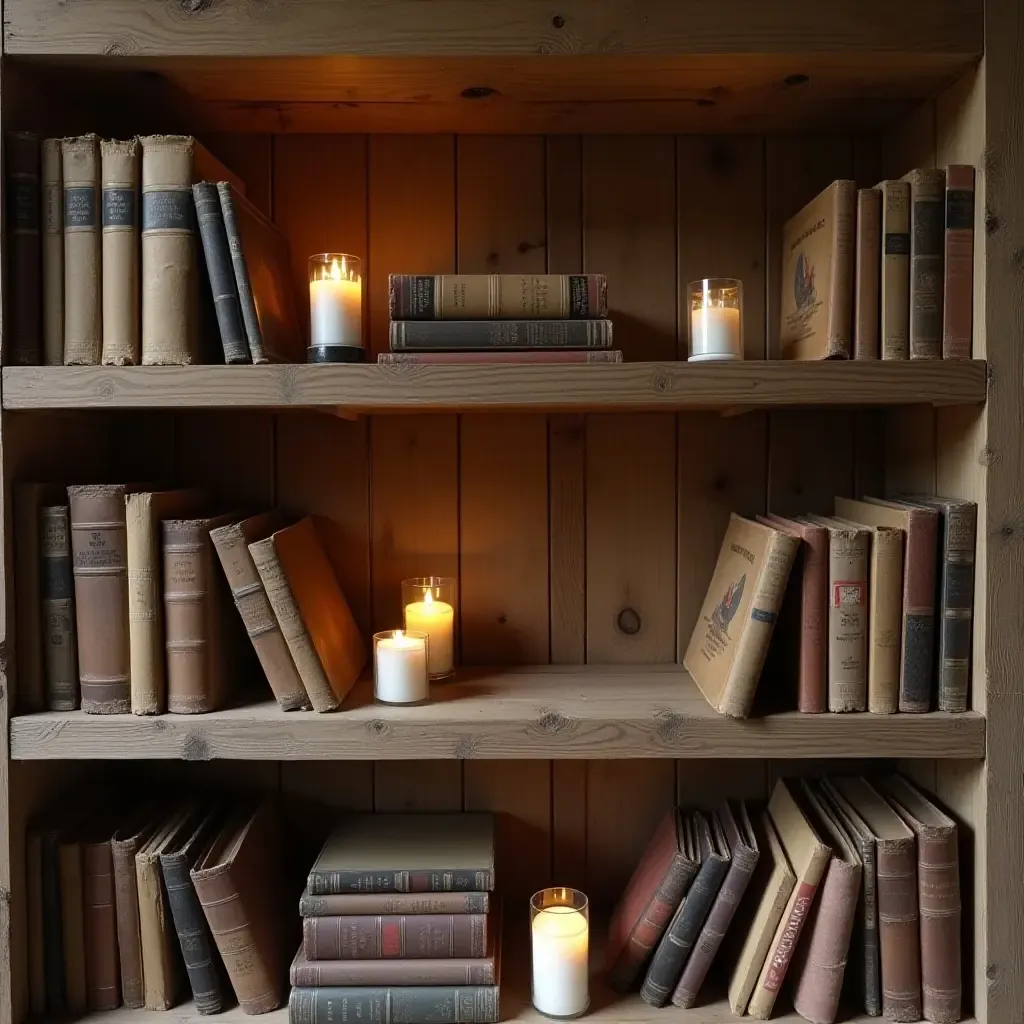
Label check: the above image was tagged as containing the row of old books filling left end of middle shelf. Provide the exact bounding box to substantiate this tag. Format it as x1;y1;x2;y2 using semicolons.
14;484;367;715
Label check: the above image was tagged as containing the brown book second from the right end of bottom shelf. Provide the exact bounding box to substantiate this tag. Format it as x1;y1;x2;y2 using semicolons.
833;777;922;1021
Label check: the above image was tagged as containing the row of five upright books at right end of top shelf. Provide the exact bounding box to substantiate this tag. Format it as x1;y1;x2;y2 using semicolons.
779;164;975;359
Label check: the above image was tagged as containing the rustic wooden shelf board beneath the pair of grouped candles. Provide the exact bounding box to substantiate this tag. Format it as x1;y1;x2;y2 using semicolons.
10;666;985;761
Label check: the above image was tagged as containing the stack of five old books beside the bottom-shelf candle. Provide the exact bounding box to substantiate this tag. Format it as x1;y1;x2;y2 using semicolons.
289;814;501;1024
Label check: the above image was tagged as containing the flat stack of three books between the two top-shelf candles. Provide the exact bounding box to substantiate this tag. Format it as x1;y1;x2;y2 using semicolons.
385;273;623;364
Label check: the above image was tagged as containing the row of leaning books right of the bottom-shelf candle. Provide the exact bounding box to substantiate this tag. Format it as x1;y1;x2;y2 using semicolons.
608;775;963;1024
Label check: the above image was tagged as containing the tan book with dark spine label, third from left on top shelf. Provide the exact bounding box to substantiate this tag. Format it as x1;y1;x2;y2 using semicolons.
61;135;103;367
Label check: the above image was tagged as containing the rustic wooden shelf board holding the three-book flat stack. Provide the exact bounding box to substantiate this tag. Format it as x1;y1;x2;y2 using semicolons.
3;359;986;413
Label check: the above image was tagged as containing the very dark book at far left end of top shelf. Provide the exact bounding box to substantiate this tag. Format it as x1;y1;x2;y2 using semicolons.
4;131;43;367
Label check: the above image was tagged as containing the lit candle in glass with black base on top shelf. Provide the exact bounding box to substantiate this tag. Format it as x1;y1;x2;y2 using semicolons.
306;253;367;362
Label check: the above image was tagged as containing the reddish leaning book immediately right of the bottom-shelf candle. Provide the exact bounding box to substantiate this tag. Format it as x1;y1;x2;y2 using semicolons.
606;808;700;992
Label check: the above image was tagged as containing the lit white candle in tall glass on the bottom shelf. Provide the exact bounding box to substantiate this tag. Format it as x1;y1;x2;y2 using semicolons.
529;888;590;1020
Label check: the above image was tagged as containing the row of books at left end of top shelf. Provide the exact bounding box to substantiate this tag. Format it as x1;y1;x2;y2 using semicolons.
7;132;302;366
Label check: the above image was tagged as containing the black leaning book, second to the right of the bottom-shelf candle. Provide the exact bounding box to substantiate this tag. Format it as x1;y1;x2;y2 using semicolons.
640;811;729;1007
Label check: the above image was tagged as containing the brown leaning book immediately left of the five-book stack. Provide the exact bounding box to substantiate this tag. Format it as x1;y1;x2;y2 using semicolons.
191;803;285;1014
